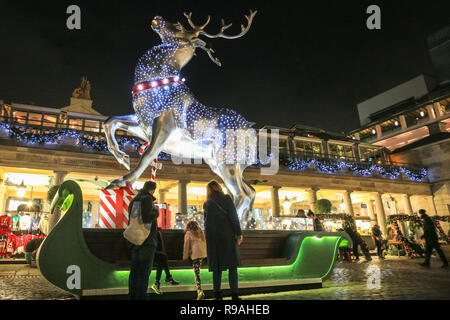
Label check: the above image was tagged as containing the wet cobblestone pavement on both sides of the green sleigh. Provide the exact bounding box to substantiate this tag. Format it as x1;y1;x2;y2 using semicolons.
0;257;450;300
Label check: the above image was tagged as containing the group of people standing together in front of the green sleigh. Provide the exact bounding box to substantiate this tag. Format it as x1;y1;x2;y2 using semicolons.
129;180;243;300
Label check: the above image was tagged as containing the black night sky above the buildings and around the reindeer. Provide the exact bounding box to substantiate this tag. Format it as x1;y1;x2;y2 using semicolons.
0;0;450;131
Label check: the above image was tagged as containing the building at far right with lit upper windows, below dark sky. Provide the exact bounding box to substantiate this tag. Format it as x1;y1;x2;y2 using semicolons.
347;27;450;232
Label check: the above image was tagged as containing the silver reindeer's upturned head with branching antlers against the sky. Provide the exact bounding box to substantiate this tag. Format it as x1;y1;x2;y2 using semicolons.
152;10;257;66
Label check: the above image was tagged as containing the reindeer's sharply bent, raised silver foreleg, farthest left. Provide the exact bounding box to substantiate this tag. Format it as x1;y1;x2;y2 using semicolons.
103;114;149;170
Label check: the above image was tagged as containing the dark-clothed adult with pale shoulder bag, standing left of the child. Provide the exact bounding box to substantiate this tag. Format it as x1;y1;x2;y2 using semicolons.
128;181;159;300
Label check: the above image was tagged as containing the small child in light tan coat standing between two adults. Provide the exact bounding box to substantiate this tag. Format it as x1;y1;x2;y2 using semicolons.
183;220;206;300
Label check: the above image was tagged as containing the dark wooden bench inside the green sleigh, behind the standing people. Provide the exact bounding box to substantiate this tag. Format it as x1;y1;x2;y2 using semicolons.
83;229;290;269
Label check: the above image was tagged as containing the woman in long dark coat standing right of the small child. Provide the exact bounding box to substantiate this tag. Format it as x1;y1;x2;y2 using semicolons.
203;180;243;300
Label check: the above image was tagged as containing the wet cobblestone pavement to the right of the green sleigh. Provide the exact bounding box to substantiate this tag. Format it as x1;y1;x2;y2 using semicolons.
243;257;450;300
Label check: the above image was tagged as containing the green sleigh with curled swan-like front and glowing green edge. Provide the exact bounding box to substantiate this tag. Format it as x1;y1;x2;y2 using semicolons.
37;181;352;298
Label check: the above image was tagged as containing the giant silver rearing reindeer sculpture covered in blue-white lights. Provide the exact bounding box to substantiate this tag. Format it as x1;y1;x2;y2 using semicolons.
103;11;256;221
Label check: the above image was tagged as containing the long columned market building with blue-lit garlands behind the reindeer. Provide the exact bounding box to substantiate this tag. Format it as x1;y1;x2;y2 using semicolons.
0;77;438;240
